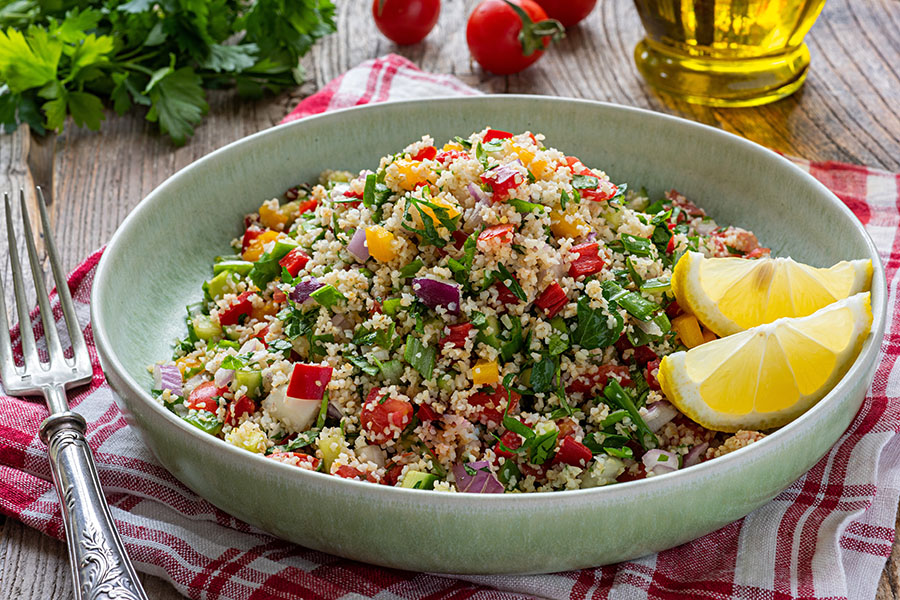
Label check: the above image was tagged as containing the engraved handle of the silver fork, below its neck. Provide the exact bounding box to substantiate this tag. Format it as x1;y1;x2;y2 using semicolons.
40;411;147;600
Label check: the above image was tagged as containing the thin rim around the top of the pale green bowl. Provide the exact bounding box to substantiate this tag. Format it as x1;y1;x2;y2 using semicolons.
90;94;887;506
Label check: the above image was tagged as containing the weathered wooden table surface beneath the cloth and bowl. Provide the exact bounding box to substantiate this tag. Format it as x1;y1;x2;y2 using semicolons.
0;0;900;600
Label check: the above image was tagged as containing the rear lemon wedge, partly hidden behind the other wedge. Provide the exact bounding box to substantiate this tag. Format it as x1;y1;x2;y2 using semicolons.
672;252;872;336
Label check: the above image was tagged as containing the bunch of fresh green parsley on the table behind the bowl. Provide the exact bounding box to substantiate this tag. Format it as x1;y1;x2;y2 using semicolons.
0;0;335;144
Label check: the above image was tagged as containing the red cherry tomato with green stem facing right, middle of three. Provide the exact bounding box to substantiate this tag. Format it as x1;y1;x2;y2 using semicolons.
466;0;564;75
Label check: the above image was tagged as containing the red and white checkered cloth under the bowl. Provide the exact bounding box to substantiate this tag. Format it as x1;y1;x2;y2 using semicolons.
0;56;900;600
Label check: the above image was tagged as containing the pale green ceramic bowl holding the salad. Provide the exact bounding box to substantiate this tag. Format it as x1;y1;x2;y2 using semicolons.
92;96;886;573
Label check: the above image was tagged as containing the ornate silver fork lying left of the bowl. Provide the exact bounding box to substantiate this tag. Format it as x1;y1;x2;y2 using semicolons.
0;188;147;600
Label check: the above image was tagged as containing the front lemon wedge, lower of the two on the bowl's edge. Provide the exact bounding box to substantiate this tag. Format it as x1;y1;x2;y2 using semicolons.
658;292;872;431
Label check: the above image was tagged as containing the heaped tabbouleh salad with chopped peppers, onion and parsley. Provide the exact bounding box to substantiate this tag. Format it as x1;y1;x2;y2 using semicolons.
152;128;769;493
